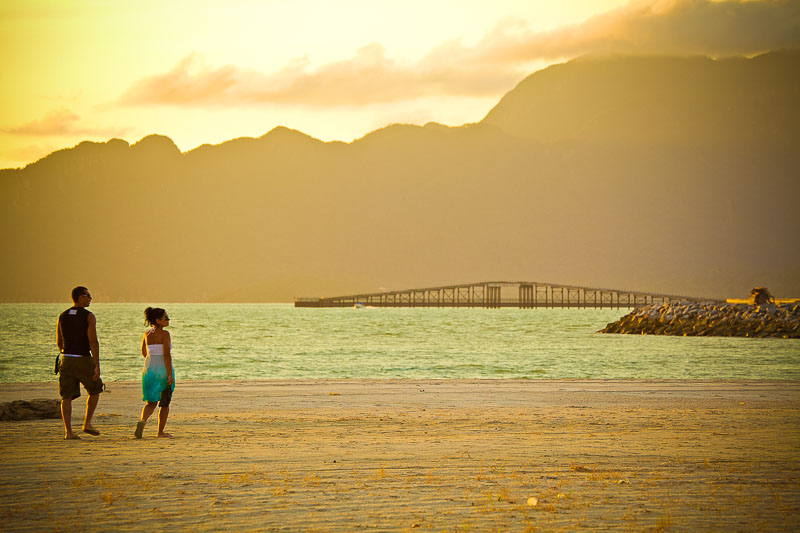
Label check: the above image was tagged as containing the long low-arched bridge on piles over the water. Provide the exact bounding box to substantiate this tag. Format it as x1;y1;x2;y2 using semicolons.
294;281;724;309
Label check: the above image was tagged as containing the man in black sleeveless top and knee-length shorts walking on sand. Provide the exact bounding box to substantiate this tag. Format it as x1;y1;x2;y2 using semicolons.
56;287;104;439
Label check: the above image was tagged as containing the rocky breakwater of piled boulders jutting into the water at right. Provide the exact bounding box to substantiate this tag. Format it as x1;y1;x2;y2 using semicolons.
599;301;800;339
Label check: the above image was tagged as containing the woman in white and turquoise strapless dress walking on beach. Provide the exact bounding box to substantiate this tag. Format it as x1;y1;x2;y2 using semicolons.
133;307;175;439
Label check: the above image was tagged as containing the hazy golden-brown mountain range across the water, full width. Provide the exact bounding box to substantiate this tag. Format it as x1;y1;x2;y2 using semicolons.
0;51;800;303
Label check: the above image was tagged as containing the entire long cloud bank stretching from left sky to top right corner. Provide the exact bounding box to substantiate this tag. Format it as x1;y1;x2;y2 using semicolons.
119;0;800;107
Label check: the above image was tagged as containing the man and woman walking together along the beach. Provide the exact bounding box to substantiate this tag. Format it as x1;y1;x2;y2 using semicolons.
56;286;175;440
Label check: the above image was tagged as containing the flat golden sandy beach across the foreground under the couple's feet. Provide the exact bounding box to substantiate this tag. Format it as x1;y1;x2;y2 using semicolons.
0;380;800;531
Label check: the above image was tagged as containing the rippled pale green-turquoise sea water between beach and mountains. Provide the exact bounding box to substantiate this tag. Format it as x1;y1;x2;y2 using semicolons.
0;303;800;382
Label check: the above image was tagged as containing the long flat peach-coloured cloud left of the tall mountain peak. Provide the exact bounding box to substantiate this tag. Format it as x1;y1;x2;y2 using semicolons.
120;43;519;107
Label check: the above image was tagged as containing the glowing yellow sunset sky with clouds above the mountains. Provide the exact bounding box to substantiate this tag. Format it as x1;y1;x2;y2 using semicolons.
0;0;800;168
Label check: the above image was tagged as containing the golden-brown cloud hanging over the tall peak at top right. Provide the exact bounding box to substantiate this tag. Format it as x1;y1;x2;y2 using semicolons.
482;0;800;64
